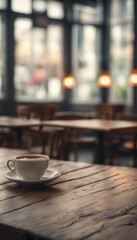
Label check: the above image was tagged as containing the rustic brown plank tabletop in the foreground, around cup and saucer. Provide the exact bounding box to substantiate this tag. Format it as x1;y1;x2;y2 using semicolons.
0;149;137;240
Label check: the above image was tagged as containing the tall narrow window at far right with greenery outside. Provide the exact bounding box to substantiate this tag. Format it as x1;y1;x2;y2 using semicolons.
110;0;134;104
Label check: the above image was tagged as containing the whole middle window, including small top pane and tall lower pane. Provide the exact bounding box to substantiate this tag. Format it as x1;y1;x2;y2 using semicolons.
72;1;103;103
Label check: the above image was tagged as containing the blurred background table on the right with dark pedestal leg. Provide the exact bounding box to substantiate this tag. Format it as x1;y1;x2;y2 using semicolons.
43;119;137;164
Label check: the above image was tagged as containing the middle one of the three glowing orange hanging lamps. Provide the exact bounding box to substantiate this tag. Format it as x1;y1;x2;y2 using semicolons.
98;72;112;88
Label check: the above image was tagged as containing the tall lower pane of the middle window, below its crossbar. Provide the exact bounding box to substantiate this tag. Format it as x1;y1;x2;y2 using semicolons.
72;25;100;103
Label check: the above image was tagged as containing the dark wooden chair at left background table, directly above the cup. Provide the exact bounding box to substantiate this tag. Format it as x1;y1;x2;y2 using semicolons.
16;104;63;157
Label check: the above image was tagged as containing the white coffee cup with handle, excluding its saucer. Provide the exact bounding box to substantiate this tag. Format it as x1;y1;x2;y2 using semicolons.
7;154;49;180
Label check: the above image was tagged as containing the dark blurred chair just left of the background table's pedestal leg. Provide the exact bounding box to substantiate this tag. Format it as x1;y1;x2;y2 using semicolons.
54;112;95;161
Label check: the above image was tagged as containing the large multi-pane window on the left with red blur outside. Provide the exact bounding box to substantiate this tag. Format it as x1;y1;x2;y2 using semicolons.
0;0;64;102
